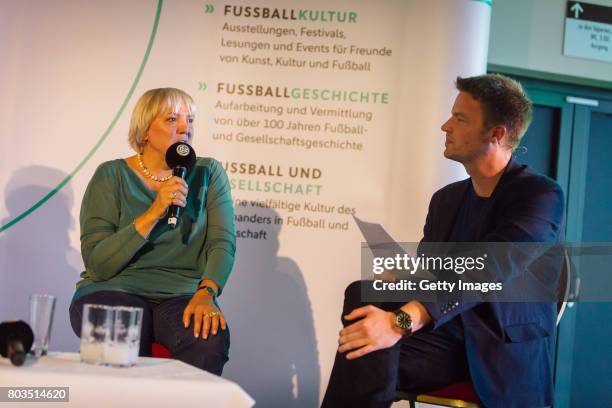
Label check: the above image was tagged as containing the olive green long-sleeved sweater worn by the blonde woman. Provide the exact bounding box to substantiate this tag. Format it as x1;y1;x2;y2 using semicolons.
73;158;236;303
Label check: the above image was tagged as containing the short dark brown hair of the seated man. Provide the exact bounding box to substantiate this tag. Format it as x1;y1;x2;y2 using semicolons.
455;74;532;150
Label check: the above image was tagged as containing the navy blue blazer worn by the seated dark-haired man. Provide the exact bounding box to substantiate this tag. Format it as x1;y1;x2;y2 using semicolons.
423;159;564;408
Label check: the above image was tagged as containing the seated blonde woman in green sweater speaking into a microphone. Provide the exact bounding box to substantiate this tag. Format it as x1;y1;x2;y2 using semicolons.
70;88;236;374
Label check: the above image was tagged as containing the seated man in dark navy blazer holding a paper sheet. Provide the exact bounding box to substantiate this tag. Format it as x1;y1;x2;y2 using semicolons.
323;75;564;407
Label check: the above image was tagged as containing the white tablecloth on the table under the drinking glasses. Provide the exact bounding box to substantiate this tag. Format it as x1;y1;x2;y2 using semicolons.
0;353;254;408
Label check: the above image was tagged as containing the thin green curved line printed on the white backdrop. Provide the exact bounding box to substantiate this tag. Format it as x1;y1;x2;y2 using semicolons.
0;0;164;232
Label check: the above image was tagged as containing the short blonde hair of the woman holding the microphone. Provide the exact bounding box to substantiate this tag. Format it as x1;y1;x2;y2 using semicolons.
128;88;196;153
